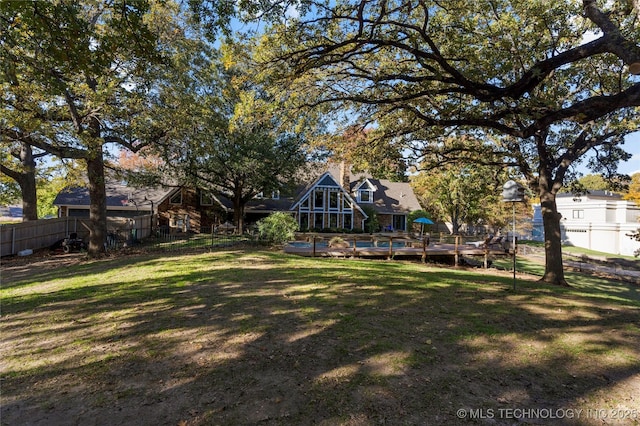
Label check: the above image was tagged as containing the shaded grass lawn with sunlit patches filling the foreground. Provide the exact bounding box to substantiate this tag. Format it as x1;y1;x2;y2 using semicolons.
0;250;640;425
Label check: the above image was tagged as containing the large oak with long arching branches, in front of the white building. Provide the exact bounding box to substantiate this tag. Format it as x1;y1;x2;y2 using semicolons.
264;0;640;284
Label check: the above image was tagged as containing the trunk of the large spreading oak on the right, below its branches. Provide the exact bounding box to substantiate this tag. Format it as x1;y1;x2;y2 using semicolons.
539;178;568;286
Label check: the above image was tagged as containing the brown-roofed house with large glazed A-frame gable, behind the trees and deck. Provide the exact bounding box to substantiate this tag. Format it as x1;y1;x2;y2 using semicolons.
54;165;421;232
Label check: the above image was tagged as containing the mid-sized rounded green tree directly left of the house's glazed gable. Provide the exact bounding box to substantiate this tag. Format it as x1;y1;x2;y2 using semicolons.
155;42;307;232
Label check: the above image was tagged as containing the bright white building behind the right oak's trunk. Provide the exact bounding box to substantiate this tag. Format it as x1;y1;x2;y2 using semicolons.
533;191;640;256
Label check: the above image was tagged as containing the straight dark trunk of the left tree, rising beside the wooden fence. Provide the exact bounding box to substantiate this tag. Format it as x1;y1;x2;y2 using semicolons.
87;150;107;257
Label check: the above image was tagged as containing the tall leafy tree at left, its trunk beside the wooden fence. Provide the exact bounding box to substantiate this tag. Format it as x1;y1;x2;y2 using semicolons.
0;0;178;255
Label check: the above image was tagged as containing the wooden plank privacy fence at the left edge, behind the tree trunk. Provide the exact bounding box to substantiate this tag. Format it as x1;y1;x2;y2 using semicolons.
0;216;151;256
